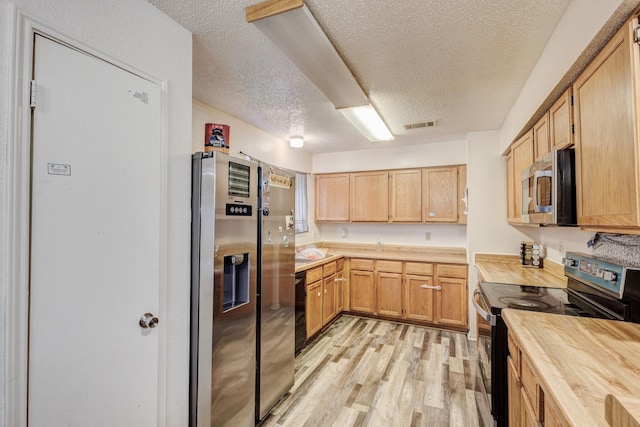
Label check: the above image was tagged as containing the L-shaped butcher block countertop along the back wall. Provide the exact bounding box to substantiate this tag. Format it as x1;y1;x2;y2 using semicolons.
296;243;467;272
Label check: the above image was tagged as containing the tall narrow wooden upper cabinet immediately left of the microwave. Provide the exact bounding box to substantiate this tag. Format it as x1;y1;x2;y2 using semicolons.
507;129;533;224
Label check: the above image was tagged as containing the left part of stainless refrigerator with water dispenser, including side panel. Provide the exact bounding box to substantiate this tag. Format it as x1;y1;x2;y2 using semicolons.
189;152;258;427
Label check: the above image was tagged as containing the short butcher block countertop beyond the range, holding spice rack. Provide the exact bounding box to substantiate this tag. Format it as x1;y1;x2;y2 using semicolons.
475;254;567;288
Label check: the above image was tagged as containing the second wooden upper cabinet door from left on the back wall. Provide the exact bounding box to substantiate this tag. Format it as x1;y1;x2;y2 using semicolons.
351;171;389;222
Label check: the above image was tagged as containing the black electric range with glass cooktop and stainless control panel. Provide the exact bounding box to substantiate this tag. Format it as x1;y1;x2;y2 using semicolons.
473;253;640;427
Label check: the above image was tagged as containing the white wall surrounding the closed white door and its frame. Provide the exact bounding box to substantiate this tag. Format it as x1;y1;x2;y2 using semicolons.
0;0;192;427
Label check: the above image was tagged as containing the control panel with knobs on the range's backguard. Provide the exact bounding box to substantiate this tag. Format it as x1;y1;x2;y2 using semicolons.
562;252;627;298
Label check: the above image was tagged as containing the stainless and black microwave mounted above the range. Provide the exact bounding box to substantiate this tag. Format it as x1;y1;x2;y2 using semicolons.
521;148;577;226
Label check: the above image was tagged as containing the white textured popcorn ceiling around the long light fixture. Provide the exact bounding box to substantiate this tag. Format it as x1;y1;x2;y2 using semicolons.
149;0;570;153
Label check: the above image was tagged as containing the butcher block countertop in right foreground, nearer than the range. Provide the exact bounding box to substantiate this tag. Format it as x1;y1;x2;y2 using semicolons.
502;309;640;426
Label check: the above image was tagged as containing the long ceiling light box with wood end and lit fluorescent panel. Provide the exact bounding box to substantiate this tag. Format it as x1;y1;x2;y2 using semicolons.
246;0;394;141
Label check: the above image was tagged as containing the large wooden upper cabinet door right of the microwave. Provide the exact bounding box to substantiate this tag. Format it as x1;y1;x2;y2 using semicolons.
573;17;640;229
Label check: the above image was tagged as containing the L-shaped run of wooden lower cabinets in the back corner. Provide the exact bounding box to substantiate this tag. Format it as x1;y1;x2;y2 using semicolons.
306;258;468;338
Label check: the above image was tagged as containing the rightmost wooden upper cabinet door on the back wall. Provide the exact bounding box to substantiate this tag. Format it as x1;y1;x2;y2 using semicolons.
422;166;458;222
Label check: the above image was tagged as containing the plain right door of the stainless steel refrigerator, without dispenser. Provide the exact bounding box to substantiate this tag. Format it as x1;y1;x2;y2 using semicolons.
256;164;295;421
